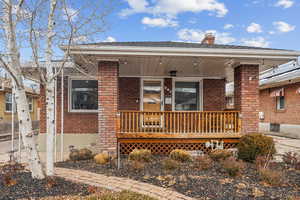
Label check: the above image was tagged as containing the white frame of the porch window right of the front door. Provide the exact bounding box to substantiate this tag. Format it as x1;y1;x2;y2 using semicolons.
172;77;203;111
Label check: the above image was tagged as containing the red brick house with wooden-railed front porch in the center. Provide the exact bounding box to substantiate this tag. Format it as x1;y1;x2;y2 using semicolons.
33;35;300;153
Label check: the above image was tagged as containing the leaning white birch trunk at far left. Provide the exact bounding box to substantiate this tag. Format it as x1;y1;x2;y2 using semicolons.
3;0;45;179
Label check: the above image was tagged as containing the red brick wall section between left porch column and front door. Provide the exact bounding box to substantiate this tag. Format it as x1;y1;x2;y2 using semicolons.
119;77;140;110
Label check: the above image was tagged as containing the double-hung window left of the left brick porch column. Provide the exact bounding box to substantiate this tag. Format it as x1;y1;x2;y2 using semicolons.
70;79;98;112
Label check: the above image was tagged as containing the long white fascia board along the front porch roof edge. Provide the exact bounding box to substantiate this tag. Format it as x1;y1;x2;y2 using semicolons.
62;46;300;60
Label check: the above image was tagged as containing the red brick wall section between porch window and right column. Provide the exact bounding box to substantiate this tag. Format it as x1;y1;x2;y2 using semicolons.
203;79;226;111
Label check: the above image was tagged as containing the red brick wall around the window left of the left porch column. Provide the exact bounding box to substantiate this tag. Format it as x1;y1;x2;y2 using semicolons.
40;77;98;134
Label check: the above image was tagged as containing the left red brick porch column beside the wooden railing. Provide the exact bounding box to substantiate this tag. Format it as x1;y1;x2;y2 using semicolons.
98;61;119;151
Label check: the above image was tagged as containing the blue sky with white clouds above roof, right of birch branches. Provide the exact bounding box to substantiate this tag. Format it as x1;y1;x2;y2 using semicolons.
100;0;300;50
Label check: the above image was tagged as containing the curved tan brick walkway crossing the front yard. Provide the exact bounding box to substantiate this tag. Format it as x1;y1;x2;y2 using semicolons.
55;168;194;200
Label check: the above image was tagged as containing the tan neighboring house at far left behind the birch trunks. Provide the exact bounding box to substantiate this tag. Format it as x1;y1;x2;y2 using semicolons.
0;77;39;133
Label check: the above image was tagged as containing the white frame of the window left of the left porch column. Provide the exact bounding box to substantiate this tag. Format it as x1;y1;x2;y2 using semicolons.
68;77;99;113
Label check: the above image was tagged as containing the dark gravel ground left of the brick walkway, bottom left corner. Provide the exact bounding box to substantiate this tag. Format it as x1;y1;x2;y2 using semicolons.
0;172;89;200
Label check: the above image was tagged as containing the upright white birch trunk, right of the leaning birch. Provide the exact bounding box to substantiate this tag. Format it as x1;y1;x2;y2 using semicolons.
45;0;57;176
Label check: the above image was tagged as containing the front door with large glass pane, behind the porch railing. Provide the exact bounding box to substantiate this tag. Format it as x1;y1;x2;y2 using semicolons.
141;79;164;127
